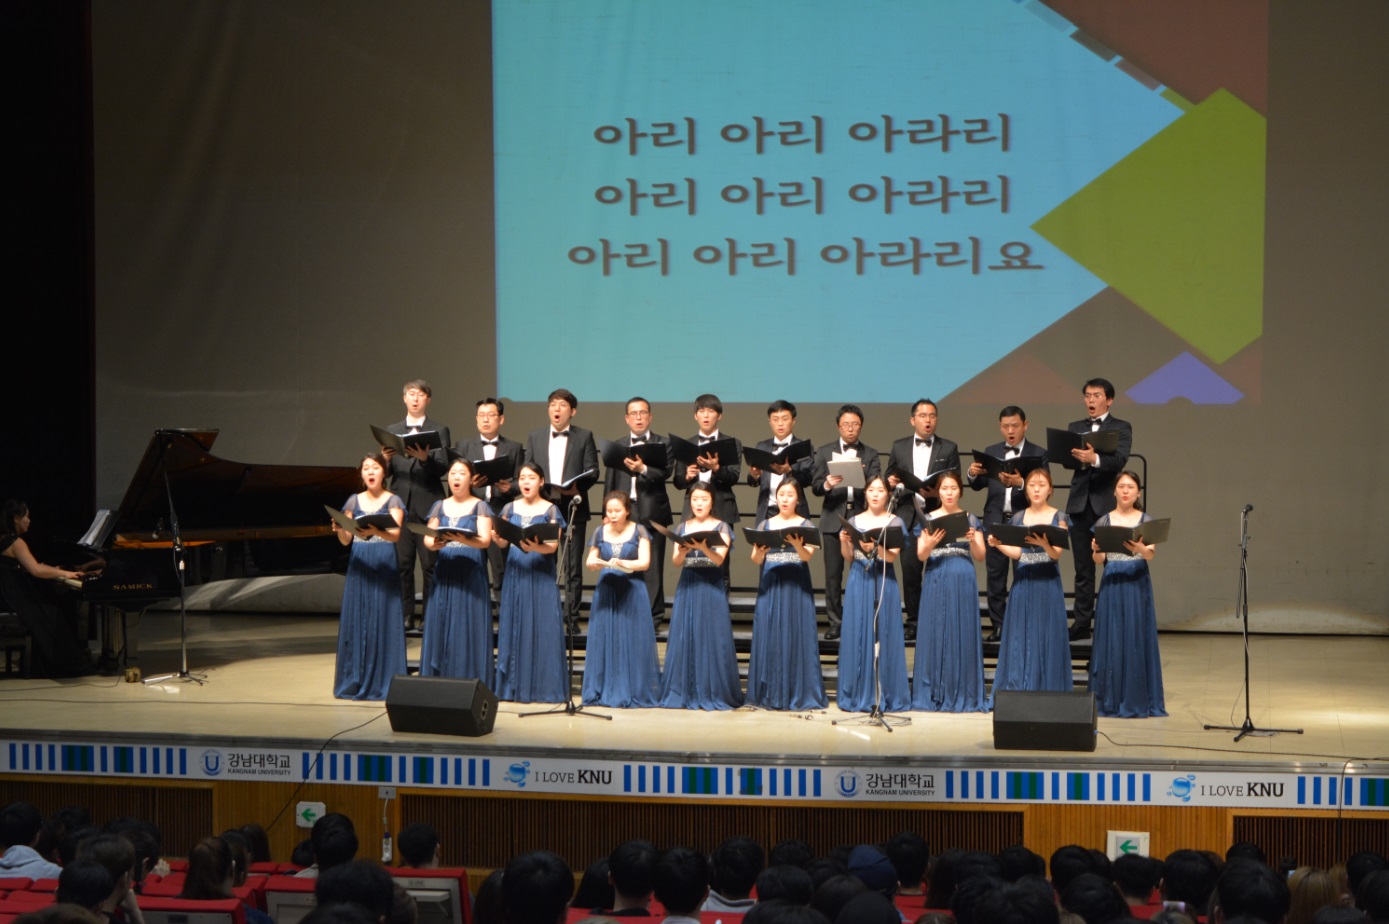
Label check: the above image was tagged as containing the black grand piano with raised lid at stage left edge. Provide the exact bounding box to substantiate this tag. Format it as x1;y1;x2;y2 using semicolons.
78;429;361;673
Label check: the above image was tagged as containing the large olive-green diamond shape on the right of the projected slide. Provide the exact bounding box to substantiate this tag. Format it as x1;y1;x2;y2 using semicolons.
1032;90;1267;363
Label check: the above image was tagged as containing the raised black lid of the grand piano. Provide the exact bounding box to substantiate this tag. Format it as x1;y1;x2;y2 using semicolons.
111;429;361;546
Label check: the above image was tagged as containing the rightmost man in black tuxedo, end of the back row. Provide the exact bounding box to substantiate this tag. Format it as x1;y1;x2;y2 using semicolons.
1065;378;1133;641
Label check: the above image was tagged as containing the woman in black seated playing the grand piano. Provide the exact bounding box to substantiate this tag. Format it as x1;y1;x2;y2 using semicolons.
0;500;96;677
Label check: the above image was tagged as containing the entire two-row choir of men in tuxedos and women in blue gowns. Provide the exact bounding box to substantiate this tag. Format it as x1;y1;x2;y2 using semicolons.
322;379;1167;717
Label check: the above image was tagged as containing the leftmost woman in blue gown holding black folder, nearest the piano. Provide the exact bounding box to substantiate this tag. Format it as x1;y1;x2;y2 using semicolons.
333;453;406;699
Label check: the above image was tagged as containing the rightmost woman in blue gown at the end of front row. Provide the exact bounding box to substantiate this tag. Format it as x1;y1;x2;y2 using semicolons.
1090;471;1167;718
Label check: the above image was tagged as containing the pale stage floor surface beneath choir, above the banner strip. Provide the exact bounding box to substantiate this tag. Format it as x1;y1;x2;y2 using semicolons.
0;613;1389;774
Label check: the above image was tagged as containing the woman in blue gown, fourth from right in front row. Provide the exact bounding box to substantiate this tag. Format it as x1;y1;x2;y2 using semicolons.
835;477;911;713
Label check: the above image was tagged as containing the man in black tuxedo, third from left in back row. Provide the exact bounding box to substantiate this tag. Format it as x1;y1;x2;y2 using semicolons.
525;388;599;625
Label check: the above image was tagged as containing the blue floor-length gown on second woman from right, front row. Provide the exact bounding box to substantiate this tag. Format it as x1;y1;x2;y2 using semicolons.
993;511;1075;693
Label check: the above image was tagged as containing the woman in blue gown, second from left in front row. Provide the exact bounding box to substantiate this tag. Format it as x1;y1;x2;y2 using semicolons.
419;459;492;689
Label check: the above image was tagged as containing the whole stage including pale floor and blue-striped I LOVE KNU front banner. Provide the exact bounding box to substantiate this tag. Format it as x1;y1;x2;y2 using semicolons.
0;611;1389;810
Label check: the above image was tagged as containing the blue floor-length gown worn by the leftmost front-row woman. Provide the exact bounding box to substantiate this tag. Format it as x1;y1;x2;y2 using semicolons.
333;495;406;699
